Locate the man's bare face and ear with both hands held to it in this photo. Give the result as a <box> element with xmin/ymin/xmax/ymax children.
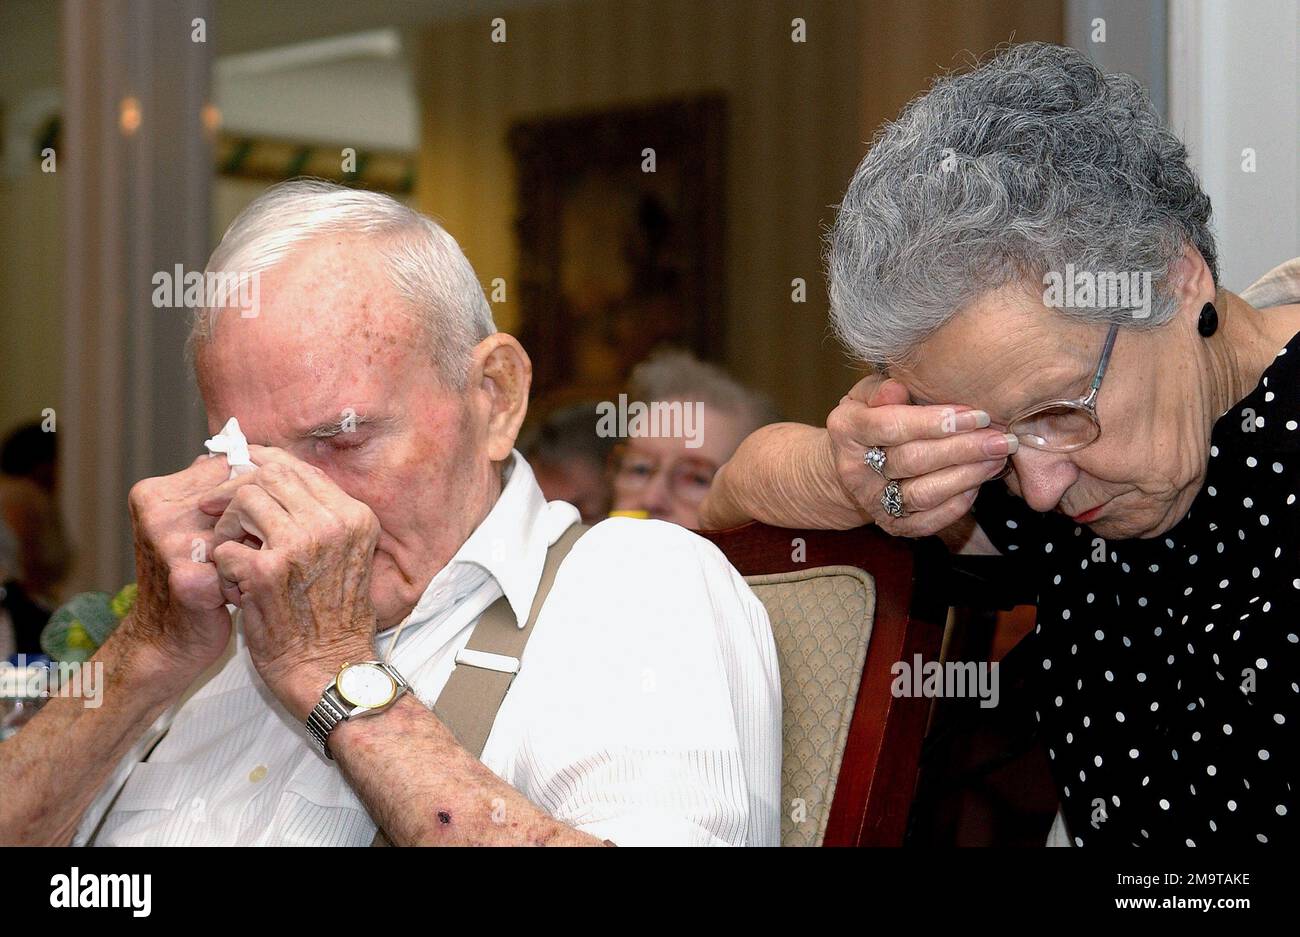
<box><xmin>122</xmin><ymin>237</ymin><xmax>530</xmax><ymax>703</ymax></box>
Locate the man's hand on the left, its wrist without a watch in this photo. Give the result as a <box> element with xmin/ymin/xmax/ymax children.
<box><xmin>122</xmin><ymin>455</ymin><xmax>245</xmax><ymax>691</ymax></box>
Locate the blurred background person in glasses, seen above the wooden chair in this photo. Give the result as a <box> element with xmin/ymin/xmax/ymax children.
<box><xmin>611</xmin><ymin>348</ymin><xmax>780</xmax><ymax>529</ymax></box>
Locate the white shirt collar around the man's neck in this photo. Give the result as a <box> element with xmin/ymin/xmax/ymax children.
<box><xmin>387</xmin><ymin>450</ymin><xmax>579</xmax><ymax>628</ymax></box>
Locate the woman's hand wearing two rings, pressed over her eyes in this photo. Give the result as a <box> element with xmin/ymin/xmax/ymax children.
<box><xmin>826</xmin><ymin>377</ymin><xmax>1019</xmax><ymax>537</ymax></box>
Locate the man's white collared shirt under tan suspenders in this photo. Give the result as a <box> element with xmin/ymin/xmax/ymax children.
<box><xmin>74</xmin><ymin>452</ymin><xmax>781</xmax><ymax>846</ymax></box>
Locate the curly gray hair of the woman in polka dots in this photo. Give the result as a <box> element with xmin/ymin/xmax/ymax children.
<box><xmin>827</xmin><ymin>43</ymin><xmax>1218</xmax><ymax>369</ymax></box>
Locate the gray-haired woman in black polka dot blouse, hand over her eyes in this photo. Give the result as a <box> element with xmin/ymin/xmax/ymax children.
<box><xmin>703</xmin><ymin>44</ymin><xmax>1300</xmax><ymax>846</ymax></box>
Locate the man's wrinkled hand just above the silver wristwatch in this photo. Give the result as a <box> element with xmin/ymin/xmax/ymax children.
<box><xmin>202</xmin><ymin>446</ymin><xmax>380</xmax><ymax>719</ymax></box>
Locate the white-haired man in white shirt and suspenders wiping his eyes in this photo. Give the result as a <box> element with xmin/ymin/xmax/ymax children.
<box><xmin>0</xmin><ymin>182</ymin><xmax>780</xmax><ymax>845</ymax></box>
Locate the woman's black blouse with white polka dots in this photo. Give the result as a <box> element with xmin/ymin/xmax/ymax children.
<box><xmin>975</xmin><ymin>335</ymin><xmax>1300</xmax><ymax>846</ymax></box>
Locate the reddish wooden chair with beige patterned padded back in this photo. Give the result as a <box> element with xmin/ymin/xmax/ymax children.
<box><xmin>699</xmin><ymin>524</ymin><xmax>948</xmax><ymax>846</ymax></box>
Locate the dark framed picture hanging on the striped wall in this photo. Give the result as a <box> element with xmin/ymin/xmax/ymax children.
<box><xmin>510</xmin><ymin>96</ymin><xmax>725</xmax><ymax>403</ymax></box>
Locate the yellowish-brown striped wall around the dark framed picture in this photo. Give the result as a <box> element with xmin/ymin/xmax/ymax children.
<box><xmin>413</xmin><ymin>0</ymin><xmax>1061</xmax><ymax>421</ymax></box>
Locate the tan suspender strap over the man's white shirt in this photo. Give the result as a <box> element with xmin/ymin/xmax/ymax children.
<box><xmin>371</xmin><ymin>524</ymin><xmax>590</xmax><ymax>846</ymax></box>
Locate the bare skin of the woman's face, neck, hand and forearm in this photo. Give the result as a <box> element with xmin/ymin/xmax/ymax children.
<box><xmin>702</xmin><ymin>246</ymin><xmax>1300</xmax><ymax>552</ymax></box>
